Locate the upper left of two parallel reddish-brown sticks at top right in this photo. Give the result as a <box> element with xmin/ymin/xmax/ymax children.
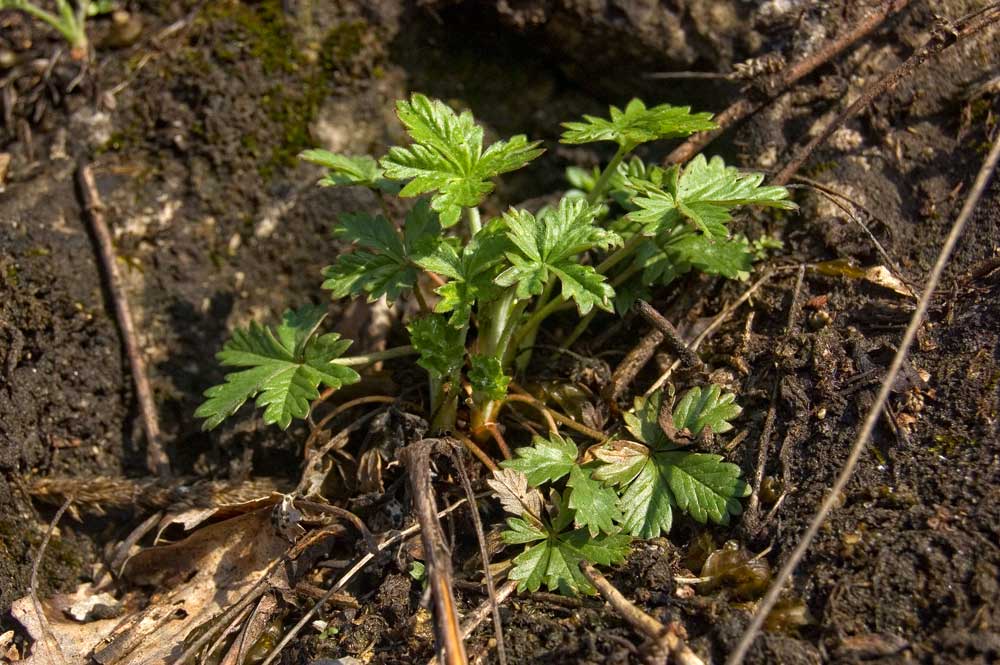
<box><xmin>665</xmin><ymin>0</ymin><xmax>910</xmax><ymax>164</ymax></box>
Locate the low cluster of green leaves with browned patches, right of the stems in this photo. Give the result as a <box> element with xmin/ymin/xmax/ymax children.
<box><xmin>489</xmin><ymin>386</ymin><xmax>750</xmax><ymax>593</ymax></box>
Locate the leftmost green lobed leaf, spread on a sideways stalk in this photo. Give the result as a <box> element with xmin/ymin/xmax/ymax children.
<box><xmin>195</xmin><ymin>306</ymin><xmax>361</xmax><ymax>430</ymax></box>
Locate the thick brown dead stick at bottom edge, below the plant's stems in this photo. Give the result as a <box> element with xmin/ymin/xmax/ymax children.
<box><xmin>402</xmin><ymin>439</ymin><xmax>468</xmax><ymax>665</ymax></box>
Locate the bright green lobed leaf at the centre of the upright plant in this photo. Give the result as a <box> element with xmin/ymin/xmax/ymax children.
<box><xmin>496</xmin><ymin>198</ymin><xmax>621</xmax><ymax>315</ymax></box>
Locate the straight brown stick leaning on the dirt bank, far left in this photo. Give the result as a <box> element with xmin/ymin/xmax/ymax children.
<box><xmin>76</xmin><ymin>164</ymin><xmax>170</xmax><ymax>478</ymax></box>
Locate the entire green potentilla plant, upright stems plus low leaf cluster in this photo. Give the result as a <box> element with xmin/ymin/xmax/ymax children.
<box><xmin>197</xmin><ymin>94</ymin><xmax>795</xmax><ymax>592</ymax></box>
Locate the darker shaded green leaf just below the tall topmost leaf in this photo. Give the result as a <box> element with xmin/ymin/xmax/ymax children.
<box><xmin>323</xmin><ymin>200</ymin><xmax>441</xmax><ymax>302</ymax></box>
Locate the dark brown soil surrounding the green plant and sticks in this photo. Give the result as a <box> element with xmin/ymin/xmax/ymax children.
<box><xmin>0</xmin><ymin>0</ymin><xmax>1000</xmax><ymax>663</ymax></box>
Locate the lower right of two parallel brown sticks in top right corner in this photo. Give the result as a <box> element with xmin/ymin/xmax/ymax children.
<box><xmin>772</xmin><ymin>3</ymin><xmax>1000</xmax><ymax>185</ymax></box>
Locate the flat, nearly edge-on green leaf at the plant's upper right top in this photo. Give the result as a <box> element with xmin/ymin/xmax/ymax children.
<box><xmin>561</xmin><ymin>99</ymin><xmax>716</xmax><ymax>150</ymax></box>
